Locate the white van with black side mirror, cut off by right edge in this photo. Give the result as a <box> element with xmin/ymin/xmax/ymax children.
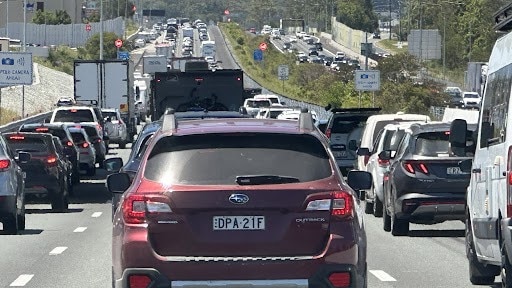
<box><xmin>450</xmin><ymin>9</ymin><xmax>512</xmax><ymax>287</ymax></box>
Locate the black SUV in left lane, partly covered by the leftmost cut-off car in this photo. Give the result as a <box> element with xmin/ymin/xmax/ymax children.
<box><xmin>4</xmin><ymin>132</ymin><xmax>69</xmax><ymax>211</ymax></box>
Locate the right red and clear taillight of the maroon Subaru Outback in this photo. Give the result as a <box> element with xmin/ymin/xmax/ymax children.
<box><xmin>306</xmin><ymin>191</ymin><xmax>354</xmax><ymax>218</ymax></box>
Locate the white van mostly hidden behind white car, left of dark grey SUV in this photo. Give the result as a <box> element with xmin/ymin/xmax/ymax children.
<box><xmin>357</xmin><ymin>112</ymin><xmax>430</xmax><ymax>171</ymax></box>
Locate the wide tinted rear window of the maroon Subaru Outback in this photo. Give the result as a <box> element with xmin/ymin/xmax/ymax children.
<box><xmin>144</xmin><ymin>133</ymin><xmax>332</xmax><ymax>185</ymax></box>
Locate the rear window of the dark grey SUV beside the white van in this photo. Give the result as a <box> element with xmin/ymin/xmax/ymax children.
<box><xmin>414</xmin><ymin>131</ymin><xmax>450</xmax><ymax>157</ymax></box>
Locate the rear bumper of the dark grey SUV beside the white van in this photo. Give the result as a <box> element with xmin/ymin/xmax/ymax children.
<box><xmin>395</xmin><ymin>193</ymin><xmax>466</xmax><ymax>224</ymax></box>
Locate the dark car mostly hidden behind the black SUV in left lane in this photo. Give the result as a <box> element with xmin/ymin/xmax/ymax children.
<box><xmin>18</xmin><ymin>123</ymin><xmax>80</xmax><ymax>184</ymax></box>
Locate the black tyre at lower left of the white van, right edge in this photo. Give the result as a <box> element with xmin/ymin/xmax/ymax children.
<box><xmin>465</xmin><ymin>214</ymin><xmax>499</xmax><ymax>285</ymax></box>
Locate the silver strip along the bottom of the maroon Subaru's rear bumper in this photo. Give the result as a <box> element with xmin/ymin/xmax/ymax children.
<box><xmin>171</xmin><ymin>279</ymin><xmax>309</xmax><ymax>288</ymax></box>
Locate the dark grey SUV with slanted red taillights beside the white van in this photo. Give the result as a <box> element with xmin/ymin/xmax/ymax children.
<box><xmin>379</xmin><ymin>122</ymin><xmax>476</xmax><ymax>236</ymax></box>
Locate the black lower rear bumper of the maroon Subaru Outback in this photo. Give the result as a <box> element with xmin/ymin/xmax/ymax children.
<box><xmin>115</xmin><ymin>265</ymin><xmax>366</xmax><ymax>288</ymax></box>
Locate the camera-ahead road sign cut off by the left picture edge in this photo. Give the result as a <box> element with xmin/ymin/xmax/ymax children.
<box><xmin>0</xmin><ymin>52</ymin><xmax>32</xmax><ymax>86</ymax></box>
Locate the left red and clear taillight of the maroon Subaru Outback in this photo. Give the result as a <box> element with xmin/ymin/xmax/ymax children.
<box><xmin>123</xmin><ymin>195</ymin><xmax>172</xmax><ymax>224</ymax></box>
